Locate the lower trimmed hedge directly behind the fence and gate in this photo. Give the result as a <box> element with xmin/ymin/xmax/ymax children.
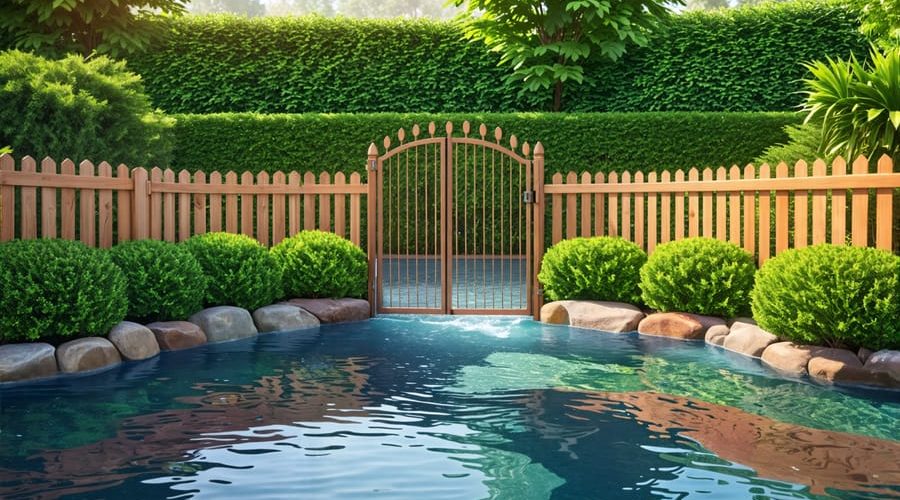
<box><xmin>173</xmin><ymin>113</ymin><xmax>802</xmax><ymax>179</ymax></box>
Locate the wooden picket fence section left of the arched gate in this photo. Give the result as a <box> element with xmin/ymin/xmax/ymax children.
<box><xmin>0</xmin><ymin>154</ymin><xmax>367</xmax><ymax>248</ymax></box>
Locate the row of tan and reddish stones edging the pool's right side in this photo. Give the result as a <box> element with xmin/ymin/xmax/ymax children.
<box><xmin>541</xmin><ymin>300</ymin><xmax>900</xmax><ymax>389</ymax></box>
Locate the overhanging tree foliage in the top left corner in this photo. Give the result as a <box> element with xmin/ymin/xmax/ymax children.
<box><xmin>0</xmin><ymin>0</ymin><xmax>185</xmax><ymax>58</ymax></box>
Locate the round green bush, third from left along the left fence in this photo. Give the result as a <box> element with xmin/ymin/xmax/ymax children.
<box><xmin>182</xmin><ymin>233</ymin><xmax>282</xmax><ymax>310</ymax></box>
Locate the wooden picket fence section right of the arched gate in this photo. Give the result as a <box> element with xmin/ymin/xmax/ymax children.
<box><xmin>544</xmin><ymin>156</ymin><xmax>900</xmax><ymax>264</ymax></box>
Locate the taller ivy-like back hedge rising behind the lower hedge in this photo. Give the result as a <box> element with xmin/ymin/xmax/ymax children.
<box><xmin>128</xmin><ymin>2</ymin><xmax>868</xmax><ymax>113</ymax></box>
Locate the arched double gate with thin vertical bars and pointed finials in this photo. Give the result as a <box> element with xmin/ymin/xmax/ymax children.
<box><xmin>368</xmin><ymin>122</ymin><xmax>544</xmax><ymax>314</ymax></box>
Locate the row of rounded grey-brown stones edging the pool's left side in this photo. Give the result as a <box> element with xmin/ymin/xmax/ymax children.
<box><xmin>0</xmin><ymin>298</ymin><xmax>369</xmax><ymax>385</ymax></box>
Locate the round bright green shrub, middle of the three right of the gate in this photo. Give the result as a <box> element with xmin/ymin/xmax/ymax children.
<box><xmin>641</xmin><ymin>238</ymin><xmax>756</xmax><ymax>317</ymax></box>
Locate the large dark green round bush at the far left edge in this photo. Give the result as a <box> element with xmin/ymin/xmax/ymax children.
<box><xmin>0</xmin><ymin>240</ymin><xmax>128</xmax><ymax>342</ymax></box>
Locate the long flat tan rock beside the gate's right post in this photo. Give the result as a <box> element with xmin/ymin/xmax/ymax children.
<box><xmin>541</xmin><ymin>300</ymin><xmax>644</xmax><ymax>333</ymax></box>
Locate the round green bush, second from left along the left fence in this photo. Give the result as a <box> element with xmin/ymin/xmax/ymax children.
<box><xmin>110</xmin><ymin>240</ymin><xmax>206</xmax><ymax>323</ymax></box>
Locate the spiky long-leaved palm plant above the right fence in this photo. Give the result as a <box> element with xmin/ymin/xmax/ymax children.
<box><xmin>803</xmin><ymin>48</ymin><xmax>900</xmax><ymax>160</ymax></box>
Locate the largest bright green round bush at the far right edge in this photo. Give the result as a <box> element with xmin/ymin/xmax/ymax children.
<box><xmin>751</xmin><ymin>244</ymin><xmax>900</xmax><ymax>349</ymax></box>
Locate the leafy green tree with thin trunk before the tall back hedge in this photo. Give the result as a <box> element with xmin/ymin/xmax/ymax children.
<box><xmin>454</xmin><ymin>0</ymin><xmax>681</xmax><ymax>111</ymax></box>
